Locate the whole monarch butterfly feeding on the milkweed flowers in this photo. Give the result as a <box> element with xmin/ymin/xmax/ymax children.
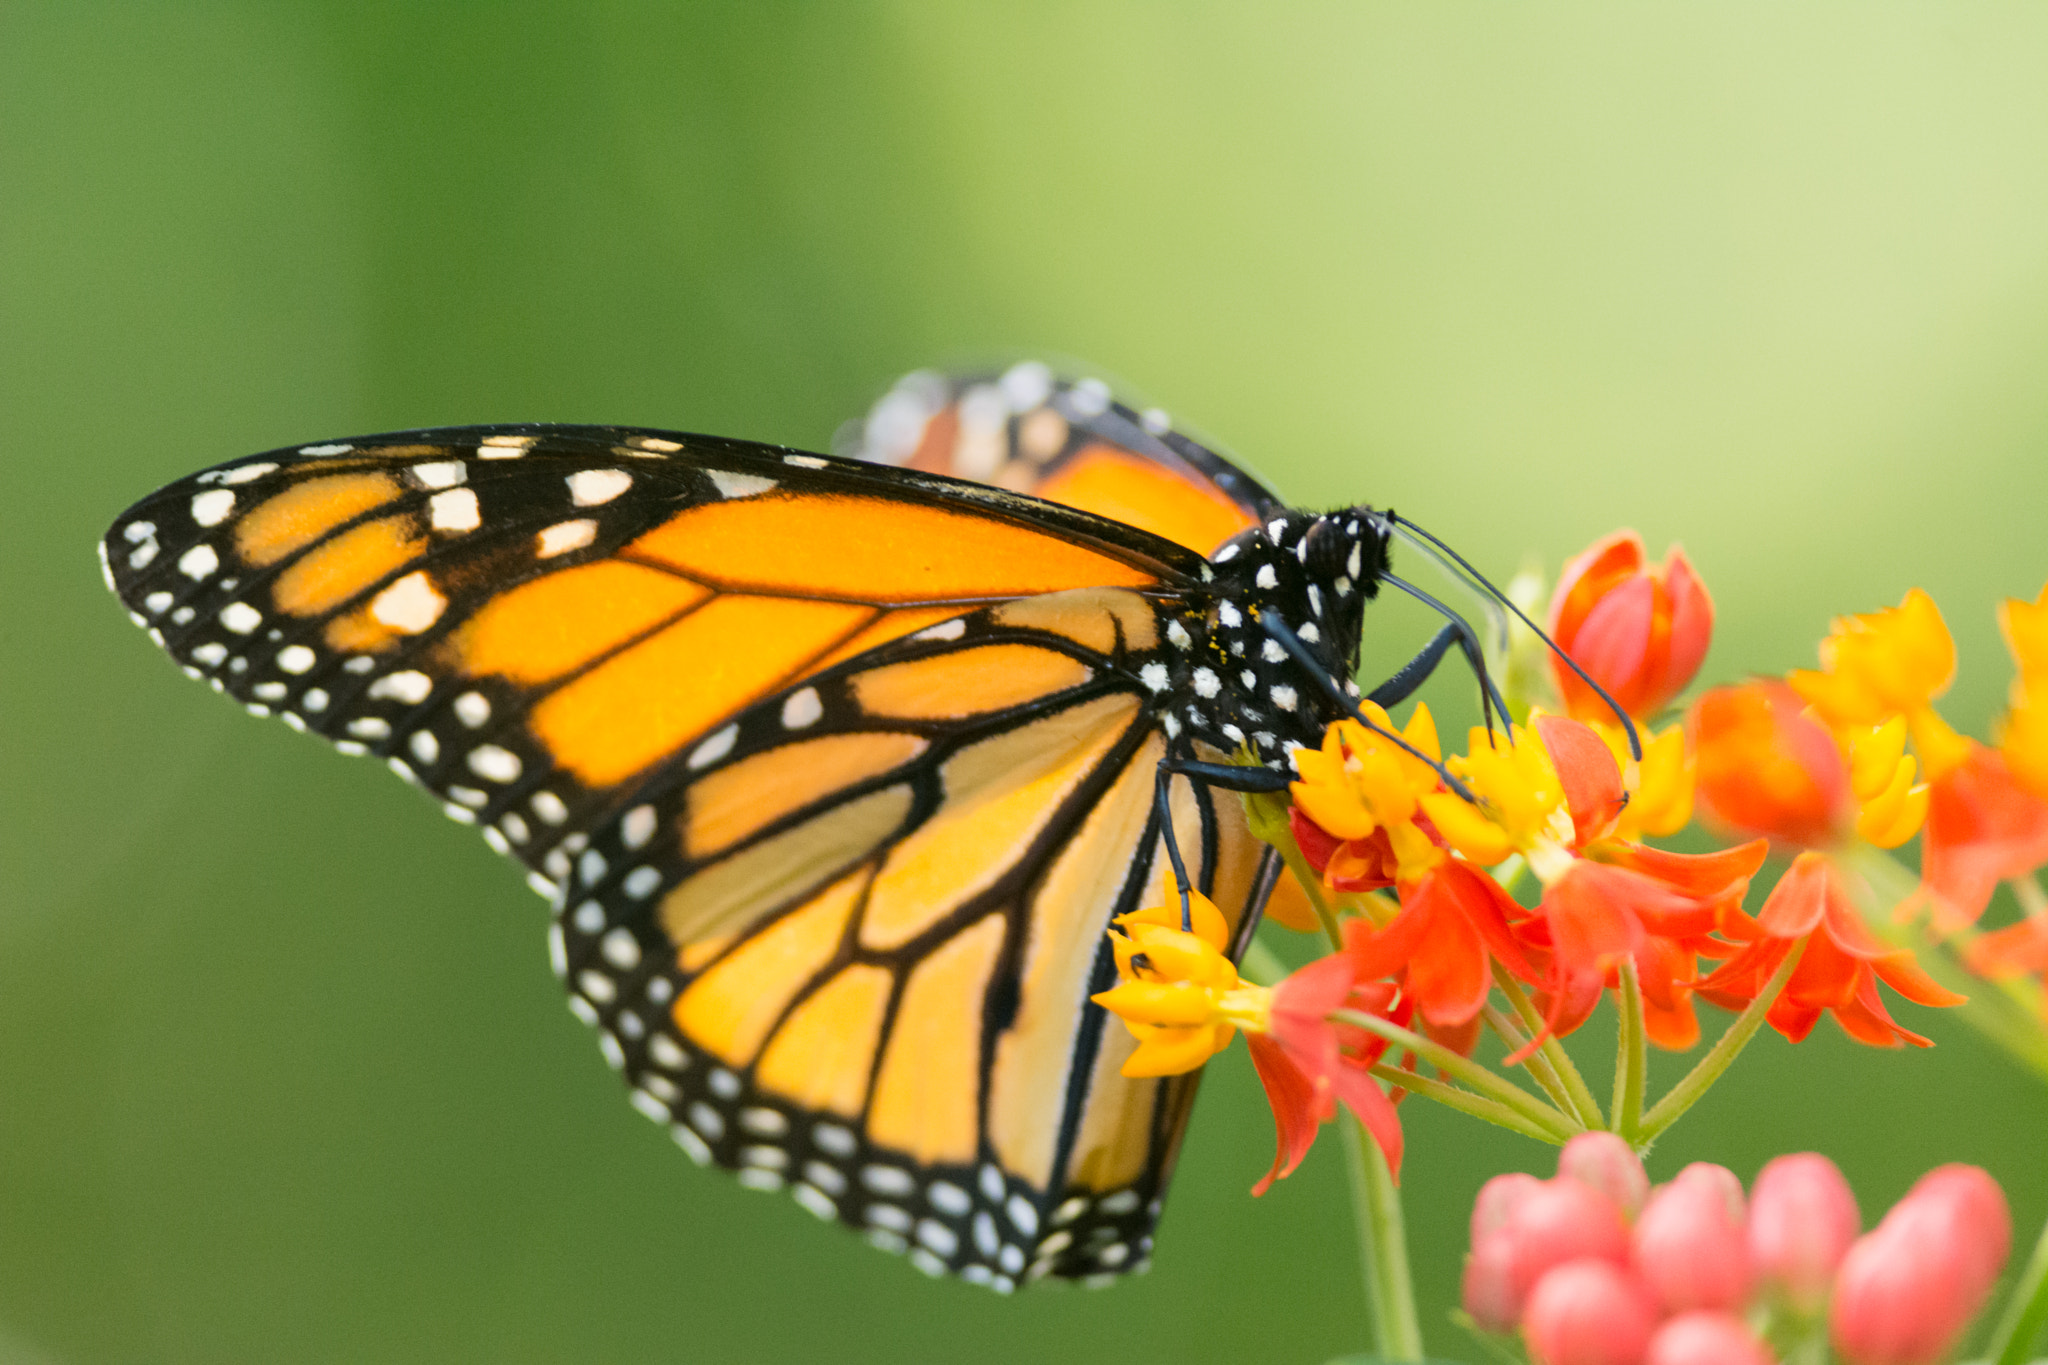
<box><xmin>100</xmin><ymin>364</ymin><xmax>1540</xmax><ymax>1291</ymax></box>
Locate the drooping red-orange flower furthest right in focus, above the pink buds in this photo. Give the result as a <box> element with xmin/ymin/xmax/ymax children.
<box><xmin>1698</xmin><ymin>851</ymin><xmax>1964</xmax><ymax>1048</ymax></box>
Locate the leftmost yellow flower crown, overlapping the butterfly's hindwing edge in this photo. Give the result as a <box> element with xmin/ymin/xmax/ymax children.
<box><xmin>1092</xmin><ymin>884</ymin><xmax>1272</xmax><ymax>1076</ymax></box>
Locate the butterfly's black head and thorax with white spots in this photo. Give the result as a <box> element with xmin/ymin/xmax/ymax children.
<box><xmin>1147</xmin><ymin>508</ymin><xmax>1389</xmax><ymax>765</ymax></box>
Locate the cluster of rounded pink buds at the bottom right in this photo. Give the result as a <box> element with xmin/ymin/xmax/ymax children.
<box><xmin>1464</xmin><ymin>1134</ymin><xmax>2011</xmax><ymax>1365</ymax></box>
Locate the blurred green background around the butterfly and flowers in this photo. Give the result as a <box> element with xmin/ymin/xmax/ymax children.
<box><xmin>0</xmin><ymin>0</ymin><xmax>2048</xmax><ymax>1365</ymax></box>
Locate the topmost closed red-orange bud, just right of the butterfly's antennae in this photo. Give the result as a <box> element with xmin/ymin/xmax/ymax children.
<box><xmin>1550</xmin><ymin>530</ymin><xmax>1714</xmax><ymax>720</ymax></box>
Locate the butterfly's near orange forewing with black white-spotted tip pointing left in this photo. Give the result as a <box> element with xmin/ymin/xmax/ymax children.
<box><xmin>102</xmin><ymin>428</ymin><xmax>1200</xmax><ymax>896</ymax></box>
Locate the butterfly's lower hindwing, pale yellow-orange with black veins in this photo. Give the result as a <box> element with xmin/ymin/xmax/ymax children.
<box><xmin>555</xmin><ymin>589</ymin><xmax>1264</xmax><ymax>1289</ymax></box>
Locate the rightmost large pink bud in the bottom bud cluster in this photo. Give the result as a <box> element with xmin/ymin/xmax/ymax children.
<box><xmin>1829</xmin><ymin>1166</ymin><xmax>2011</xmax><ymax>1365</ymax></box>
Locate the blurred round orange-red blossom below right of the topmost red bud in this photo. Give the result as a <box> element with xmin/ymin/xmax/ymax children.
<box><xmin>1688</xmin><ymin>679</ymin><xmax>1853</xmax><ymax>847</ymax></box>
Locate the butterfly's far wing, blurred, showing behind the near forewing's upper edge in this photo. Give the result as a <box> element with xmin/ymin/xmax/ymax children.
<box><xmin>846</xmin><ymin>360</ymin><xmax>1280</xmax><ymax>555</ymax></box>
